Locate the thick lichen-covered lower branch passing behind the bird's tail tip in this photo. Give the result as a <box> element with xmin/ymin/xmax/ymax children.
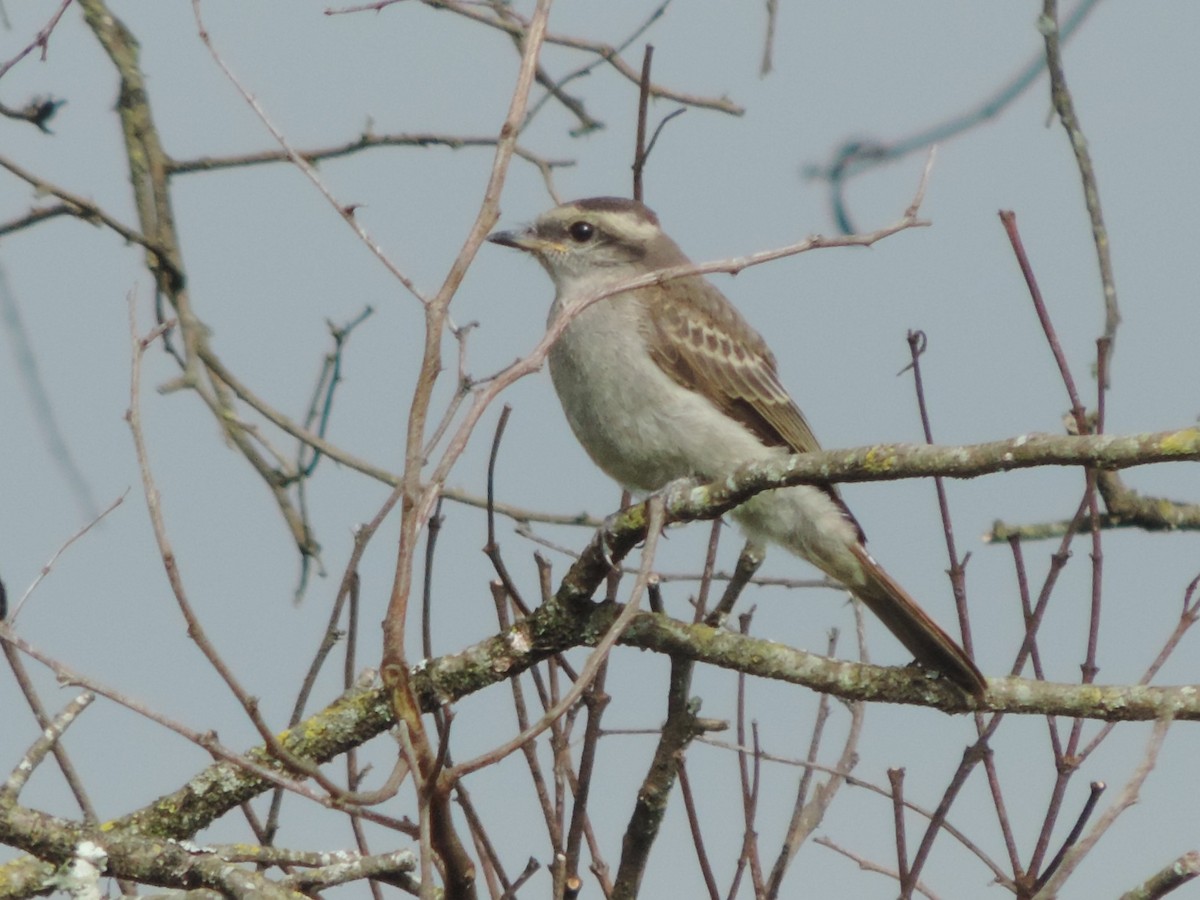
<box><xmin>7</xmin><ymin>585</ymin><xmax>1200</xmax><ymax>887</ymax></box>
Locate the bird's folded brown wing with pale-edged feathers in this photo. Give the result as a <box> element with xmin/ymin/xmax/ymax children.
<box><xmin>642</xmin><ymin>277</ymin><xmax>865</xmax><ymax>540</ymax></box>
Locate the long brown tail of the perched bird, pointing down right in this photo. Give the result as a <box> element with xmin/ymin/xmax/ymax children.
<box><xmin>853</xmin><ymin>544</ymin><xmax>988</xmax><ymax>697</ymax></box>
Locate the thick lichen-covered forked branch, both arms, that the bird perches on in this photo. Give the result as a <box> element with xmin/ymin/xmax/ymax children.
<box><xmin>0</xmin><ymin>428</ymin><xmax>1200</xmax><ymax>880</ymax></box>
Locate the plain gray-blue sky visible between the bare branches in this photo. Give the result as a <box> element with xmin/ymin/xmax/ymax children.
<box><xmin>0</xmin><ymin>0</ymin><xmax>1200</xmax><ymax>898</ymax></box>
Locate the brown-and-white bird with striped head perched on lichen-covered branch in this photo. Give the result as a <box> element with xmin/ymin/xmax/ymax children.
<box><xmin>488</xmin><ymin>197</ymin><xmax>986</xmax><ymax>697</ymax></box>
